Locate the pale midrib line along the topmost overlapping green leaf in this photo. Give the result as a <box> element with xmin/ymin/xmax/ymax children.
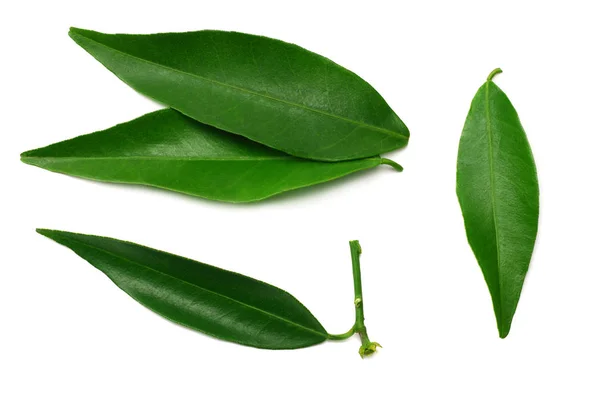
<box><xmin>71</xmin><ymin>31</ymin><xmax>408</xmax><ymax>140</ymax></box>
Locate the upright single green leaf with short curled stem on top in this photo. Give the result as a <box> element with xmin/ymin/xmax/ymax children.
<box><xmin>456</xmin><ymin>69</ymin><xmax>539</xmax><ymax>338</ymax></box>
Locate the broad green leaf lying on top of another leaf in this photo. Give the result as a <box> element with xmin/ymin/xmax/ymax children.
<box><xmin>69</xmin><ymin>28</ymin><xmax>409</xmax><ymax>161</ymax></box>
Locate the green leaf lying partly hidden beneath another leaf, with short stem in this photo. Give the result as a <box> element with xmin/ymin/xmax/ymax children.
<box><xmin>21</xmin><ymin>109</ymin><xmax>402</xmax><ymax>202</ymax></box>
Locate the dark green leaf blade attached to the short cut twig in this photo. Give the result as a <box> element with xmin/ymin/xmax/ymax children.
<box><xmin>37</xmin><ymin>229</ymin><xmax>328</xmax><ymax>349</ymax></box>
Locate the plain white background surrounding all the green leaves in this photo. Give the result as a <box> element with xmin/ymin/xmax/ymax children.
<box><xmin>0</xmin><ymin>0</ymin><xmax>600</xmax><ymax>400</ymax></box>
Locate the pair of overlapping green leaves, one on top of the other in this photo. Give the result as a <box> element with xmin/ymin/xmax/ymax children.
<box><xmin>22</xmin><ymin>28</ymin><xmax>409</xmax><ymax>202</ymax></box>
